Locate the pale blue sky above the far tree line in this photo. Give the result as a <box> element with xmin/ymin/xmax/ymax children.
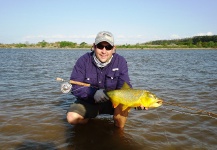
<box><xmin>0</xmin><ymin>0</ymin><xmax>217</xmax><ymax>45</ymax></box>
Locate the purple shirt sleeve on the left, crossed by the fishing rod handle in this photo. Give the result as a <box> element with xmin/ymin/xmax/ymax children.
<box><xmin>70</xmin><ymin>56</ymin><xmax>98</xmax><ymax>103</ymax></box>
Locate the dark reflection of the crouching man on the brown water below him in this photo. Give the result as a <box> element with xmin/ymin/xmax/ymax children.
<box><xmin>66</xmin><ymin>118</ymin><xmax>141</xmax><ymax>150</ymax></box>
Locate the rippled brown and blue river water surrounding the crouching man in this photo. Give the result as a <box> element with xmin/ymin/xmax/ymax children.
<box><xmin>0</xmin><ymin>49</ymin><xmax>217</xmax><ymax>150</ymax></box>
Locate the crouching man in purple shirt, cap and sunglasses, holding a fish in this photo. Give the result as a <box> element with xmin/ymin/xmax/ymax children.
<box><xmin>67</xmin><ymin>31</ymin><xmax>132</xmax><ymax>128</ymax></box>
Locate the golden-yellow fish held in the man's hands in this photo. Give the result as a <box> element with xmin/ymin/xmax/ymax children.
<box><xmin>106</xmin><ymin>83</ymin><xmax>163</xmax><ymax>110</ymax></box>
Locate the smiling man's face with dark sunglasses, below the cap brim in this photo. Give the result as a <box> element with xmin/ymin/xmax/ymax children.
<box><xmin>94</xmin><ymin>42</ymin><xmax>115</xmax><ymax>63</ymax></box>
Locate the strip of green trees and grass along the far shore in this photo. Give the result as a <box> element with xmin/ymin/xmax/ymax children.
<box><xmin>0</xmin><ymin>35</ymin><xmax>217</xmax><ymax>49</ymax></box>
